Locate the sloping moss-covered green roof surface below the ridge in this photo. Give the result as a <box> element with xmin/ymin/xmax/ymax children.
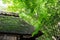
<box><xmin>0</xmin><ymin>15</ymin><xmax>34</xmax><ymax>34</ymax></box>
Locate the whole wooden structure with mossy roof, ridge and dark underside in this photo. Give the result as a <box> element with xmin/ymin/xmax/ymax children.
<box><xmin>0</xmin><ymin>11</ymin><xmax>43</xmax><ymax>40</ymax></box>
